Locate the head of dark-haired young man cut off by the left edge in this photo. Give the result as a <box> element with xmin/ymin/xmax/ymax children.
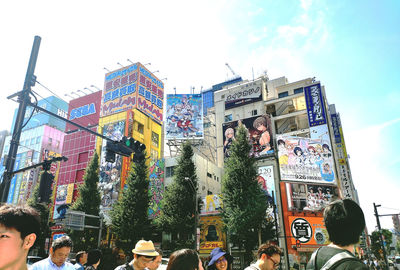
<box><xmin>0</xmin><ymin>204</ymin><xmax>40</xmax><ymax>269</ymax></box>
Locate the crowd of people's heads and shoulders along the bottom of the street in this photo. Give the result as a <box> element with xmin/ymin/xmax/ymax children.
<box><xmin>0</xmin><ymin>199</ymin><xmax>382</xmax><ymax>270</ymax></box>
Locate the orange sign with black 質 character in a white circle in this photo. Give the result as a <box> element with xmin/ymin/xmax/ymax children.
<box><xmin>288</xmin><ymin>216</ymin><xmax>329</xmax><ymax>246</ymax></box>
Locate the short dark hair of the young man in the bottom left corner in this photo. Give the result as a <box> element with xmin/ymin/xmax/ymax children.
<box><xmin>0</xmin><ymin>204</ymin><xmax>40</xmax><ymax>240</ymax></box>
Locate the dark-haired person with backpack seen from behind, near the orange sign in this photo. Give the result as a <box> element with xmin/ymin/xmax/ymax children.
<box><xmin>307</xmin><ymin>199</ymin><xmax>368</xmax><ymax>270</ymax></box>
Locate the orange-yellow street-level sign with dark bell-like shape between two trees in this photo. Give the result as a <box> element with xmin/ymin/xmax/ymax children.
<box><xmin>199</xmin><ymin>216</ymin><xmax>226</xmax><ymax>254</ymax></box>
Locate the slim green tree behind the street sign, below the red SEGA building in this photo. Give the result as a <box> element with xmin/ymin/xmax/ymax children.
<box><xmin>70</xmin><ymin>152</ymin><xmax>101</xmax><ymax>251</ymax></box>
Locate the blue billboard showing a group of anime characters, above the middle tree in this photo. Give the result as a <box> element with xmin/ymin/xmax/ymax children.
<box><xmin>165</xmin><ymin>94</ymin><xmax>204</xmax><ymax>140</ymax></box>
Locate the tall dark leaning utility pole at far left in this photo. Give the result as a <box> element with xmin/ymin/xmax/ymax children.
<box><xmin>0</xmin><ymin>36</ymin><xmax>41</xmax><ymax>202</ymax></box>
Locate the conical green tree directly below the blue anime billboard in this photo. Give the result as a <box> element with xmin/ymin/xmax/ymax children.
<box><xmin>155</xmin><ymin>142</ymin><xmax>200</xmax><ymax>250</ymax></box>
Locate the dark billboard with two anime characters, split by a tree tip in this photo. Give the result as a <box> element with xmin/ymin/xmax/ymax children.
<box><xmin>222</xmin><ymin>114</ymin><xmax>274</xmax><ymax>158</ymax></box>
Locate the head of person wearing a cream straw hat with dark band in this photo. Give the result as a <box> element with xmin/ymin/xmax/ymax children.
<box><xmin>132</xmin><ymin>240</ymin><xmax>159</xmax><ymax>270</ymax></box>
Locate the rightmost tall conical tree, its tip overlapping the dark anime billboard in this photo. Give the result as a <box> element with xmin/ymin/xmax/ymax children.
<box><xmin>222</xmin><ymin>125</ymin><xmax>268</xmax><ymax>264</ymax></box>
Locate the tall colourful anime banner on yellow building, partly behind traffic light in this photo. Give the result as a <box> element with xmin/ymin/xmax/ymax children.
<box><xmin>99</xmin><ymin>121</ymin><xmax>125</xmax><ymax>225</ymax></box>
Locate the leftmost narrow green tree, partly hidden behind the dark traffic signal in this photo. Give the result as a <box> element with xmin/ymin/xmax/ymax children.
<box><xmin>28</xmin><ymin>180</ymin><xmax>50</xmax><ymax>256</ymax></box>
